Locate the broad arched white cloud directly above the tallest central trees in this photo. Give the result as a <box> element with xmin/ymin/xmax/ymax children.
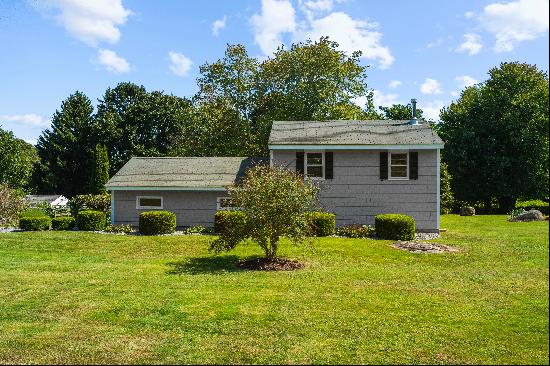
<box><xmin>295</xmin><ymin>12</ymin><xmax>394</xmax><ymax>69</ymax></box>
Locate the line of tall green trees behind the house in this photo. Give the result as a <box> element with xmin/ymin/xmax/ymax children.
<box><xmin>0</xmin><ymin>38</ymin><xmax>548</xmax><ymax>212</ymax></box>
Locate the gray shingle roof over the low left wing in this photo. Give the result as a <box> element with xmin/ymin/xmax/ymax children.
<box><xmin>106</xmin><ymin>157</ymin><xmax>262</xmax><ymax>189</ymax></box>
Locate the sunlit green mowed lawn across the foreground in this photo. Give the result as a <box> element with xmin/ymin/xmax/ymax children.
<box><xmin>0</xmin><ymin>215</ymin><xmax>549</xmax><ymax>364</ymax></box>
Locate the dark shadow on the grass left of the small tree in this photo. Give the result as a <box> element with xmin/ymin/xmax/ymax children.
<box><xmin>166</xmin><ymin>255</ymin><xmax>242</xmax><ymax>275</ymax></box>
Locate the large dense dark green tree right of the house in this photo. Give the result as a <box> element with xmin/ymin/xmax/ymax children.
<box><xmin>437</xmin><ymin>62</ymin><xmax>549</xmax><ymax>212</ymax></box>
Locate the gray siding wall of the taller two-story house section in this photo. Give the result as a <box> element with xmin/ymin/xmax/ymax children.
<box><xmin>272</xmin><ymin>149</ymin><xmax>438</xmax><ymax>231</ymax></box>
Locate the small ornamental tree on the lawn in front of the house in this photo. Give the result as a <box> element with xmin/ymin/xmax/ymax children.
<box><xmin>210</xmin><ymin>165</ymin><xmax>319</xmax><ymax>259</ymax></box>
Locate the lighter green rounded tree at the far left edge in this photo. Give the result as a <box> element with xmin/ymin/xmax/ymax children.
<box><xmin>0</xmin><ymin>128</ymin><xmax>38</xmax><ymax>188</ymax></box>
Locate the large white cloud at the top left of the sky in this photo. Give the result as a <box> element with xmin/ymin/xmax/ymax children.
<box><xmin>42</xmin><ymin>0</ymin><xmax>132</xmax><ymax>47</ymax></box>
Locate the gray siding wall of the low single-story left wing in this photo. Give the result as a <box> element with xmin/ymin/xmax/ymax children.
<box><xmin>111</xmin><ymin>191</ymin><xmax>227</xmax><ymax>227</ymax></box>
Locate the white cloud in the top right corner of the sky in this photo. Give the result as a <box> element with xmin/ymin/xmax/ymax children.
<box><xmin>480</xmin><ymin>0</ymin><xmax>549</xmax><ymax>52</ymax></box>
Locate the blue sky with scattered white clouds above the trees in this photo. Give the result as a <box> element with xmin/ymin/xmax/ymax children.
<box><xmin>0</xmin><ymin>0</ymin><xmax>549</xmax><ymax>143</ymax></box>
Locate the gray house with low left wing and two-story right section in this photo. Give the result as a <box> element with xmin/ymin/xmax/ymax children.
<box><xmin>106</xmin><ymin>119</ymin><xmax>443</xmax><ymax>232</ymax></box>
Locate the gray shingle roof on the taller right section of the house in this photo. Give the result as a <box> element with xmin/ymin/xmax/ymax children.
<box><xmin>269</xmin><ymin>120</ymin><xmax>443</xmax><ymax>145</ymax></box>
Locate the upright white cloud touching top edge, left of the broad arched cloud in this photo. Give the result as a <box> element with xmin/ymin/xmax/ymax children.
<box><xmin>251</xmin><ymin>0</ymin><xmax>296</xmax><ymax>55</ymax></box>
